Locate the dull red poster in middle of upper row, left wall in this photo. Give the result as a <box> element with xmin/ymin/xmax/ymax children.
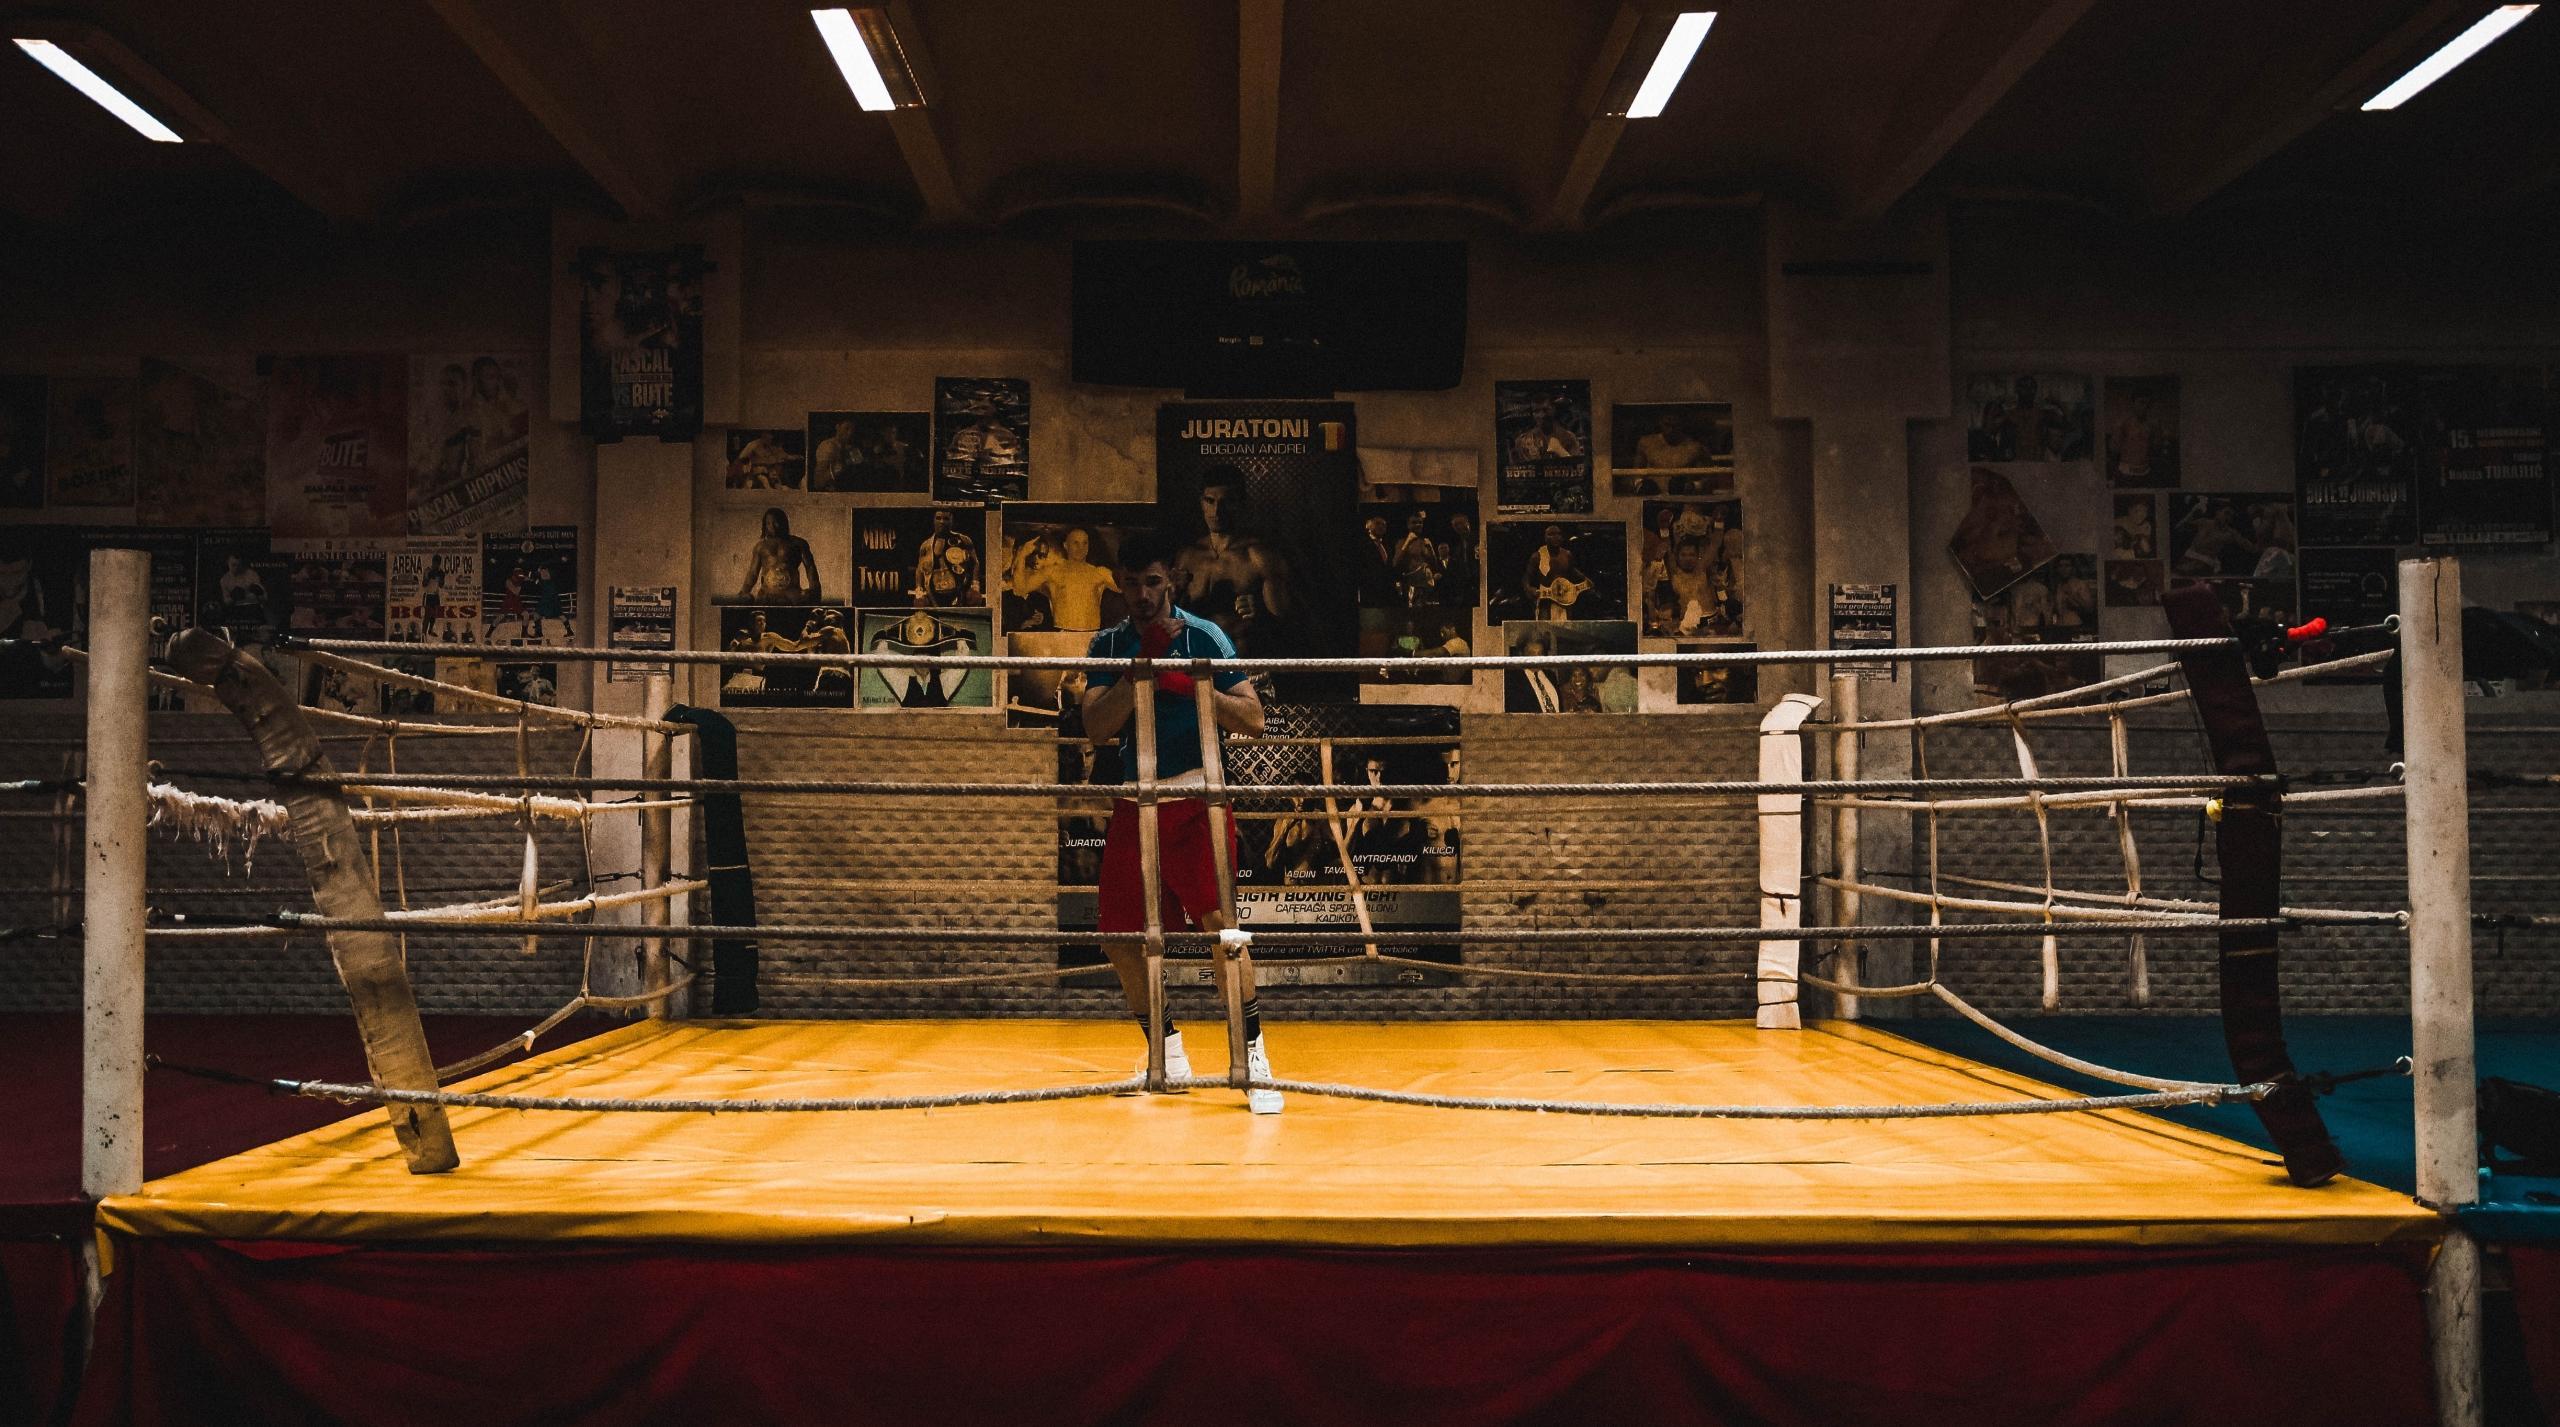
<box><xmin>259</xmin><ymin>354</ymin><xmax>410</xmax><ymax>551</ymax></box>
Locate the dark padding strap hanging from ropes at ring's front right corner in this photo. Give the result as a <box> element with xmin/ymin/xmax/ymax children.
<box><xmin>2160</xmin><ymin>584</ymin><xmax>2345</xmax><ymax>1186</ymax></box>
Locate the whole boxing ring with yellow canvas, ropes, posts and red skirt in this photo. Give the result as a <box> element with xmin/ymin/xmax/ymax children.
<box><xmin>20</xmin><ymin>551</ymin><xmax>2539</xmax><ymax>1422</ymax></box>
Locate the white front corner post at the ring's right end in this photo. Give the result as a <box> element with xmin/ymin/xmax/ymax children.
<box><xmin>2399</xmin><ymin>556</ymin><xmax>2483</xmax><ymax>1427</ymax></box>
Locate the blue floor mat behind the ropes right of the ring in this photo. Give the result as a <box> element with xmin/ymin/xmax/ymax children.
<box><xmin>1871</xmin><ymin>1015</ymin><xmax>2560</xmax><ymax>1243</ymax></box>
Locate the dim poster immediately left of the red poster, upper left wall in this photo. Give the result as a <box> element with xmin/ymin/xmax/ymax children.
<box><xmin>133</xmin><ymin>356</ymin><xmax>266</xmax><ymax>525</ymax></box>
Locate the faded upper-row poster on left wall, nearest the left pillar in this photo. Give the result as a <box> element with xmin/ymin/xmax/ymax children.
<box><xmin>410</xmin><ymin>351</ymin><xmax>543</xmax><ymax>535</ymax></box>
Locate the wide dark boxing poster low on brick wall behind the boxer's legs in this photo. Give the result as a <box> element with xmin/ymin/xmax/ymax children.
<box><xmin>1057</xmin><ymin>696</ymin><xmax>1464</xmax><ymax>986</ymax></box>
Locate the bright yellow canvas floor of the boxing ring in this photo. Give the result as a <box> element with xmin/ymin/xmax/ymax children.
<box><xmin>100</xmin><ymin>1020</ymin><xmax>2437</xmax><ymax>1248</ymax></box>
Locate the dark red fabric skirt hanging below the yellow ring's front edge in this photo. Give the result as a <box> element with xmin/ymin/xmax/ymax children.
<box><xmin>82</xmin><ymin>1240</ymin><xmax>2432</xmax><ymax>1427</ymax></box>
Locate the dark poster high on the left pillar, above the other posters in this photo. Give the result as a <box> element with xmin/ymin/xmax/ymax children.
<box><xmin>579</xmin><ymin>243</ymin><xmax>709</xmax><ymax>441</ymax></box>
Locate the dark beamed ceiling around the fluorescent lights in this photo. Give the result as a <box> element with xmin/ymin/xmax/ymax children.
<box><xmin>0</xmin><ymin>0</ymin><xmax>2560</xmax><ymax>233</ymax></box>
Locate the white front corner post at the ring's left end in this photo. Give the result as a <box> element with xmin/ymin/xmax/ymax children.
<box><xmin>79</xmin><ymin>551</ymin><xmax>151</xmax><ymax>1199</ymax></box>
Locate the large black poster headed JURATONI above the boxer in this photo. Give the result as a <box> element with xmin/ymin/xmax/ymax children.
<box><xmin>1155</xmin><ymin>402</ymin><xmax>1359</xmax><ymax>702</ymax></box>
